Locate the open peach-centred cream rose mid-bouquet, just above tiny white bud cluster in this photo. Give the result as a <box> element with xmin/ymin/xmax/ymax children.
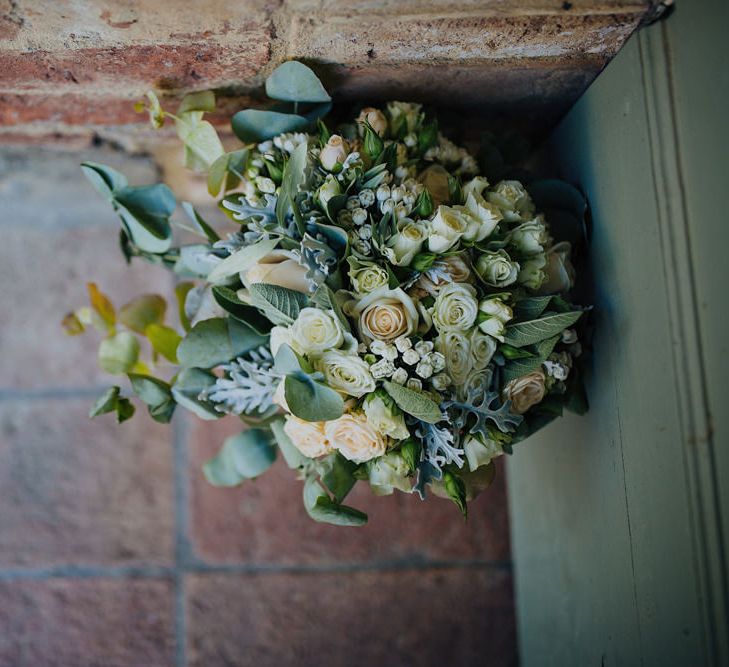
<box><xmin>345</xmin><ymin>287</ymin><xmax>418</xmax><ymax>342</ymax></box>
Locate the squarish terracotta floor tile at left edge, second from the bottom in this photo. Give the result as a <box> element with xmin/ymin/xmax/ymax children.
<box><xmin>0</xmin><ymin>398</ymin><xmax>174</xmax><ymax>568</ymax></box>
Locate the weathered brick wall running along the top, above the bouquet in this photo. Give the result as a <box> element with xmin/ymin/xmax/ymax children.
<box><xmin>0</xmin><ymin>0</ymin><xmax>650</xmax><ymax>141</ymax></box>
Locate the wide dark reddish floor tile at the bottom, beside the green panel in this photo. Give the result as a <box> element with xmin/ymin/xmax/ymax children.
<box><xmin>187</xmin><ymin>570</ymin><xmax>517</xmax><ymax>667</ymax></box>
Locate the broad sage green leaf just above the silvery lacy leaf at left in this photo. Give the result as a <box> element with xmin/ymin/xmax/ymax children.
<box><xmin>177</xmin><ymin>317</ymin><xmax>267</xmax><ymax>368</ymax></box>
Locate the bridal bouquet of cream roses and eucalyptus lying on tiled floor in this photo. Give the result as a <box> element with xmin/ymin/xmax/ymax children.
<box><xmin>64</xmin><ymin>62</ymin><xmax>585</xmax><ymax>525</ymax></box>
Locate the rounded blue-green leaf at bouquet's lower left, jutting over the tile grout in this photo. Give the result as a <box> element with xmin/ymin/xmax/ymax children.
<box><xmin>203</xmin><ymin>428</ymin><xmax>276</xmax><ymax>486</ymax></box>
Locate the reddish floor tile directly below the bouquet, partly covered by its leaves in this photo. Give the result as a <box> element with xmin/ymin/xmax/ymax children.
<box><xmin>185</xmin><ymin>418</ymin><xmax>509</xmax><ymax>564</ymax></box>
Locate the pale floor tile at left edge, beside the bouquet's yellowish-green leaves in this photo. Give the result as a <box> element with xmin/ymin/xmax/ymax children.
<box><xmin>0</xmin><ymin>150</ymin><xmax>174</xmax><ymax>389</ymax></box>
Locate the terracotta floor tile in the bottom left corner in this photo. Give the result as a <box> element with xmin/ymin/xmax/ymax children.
<box><xmin>0</xmin><ymin>579</ymin><xmax>174</xmax><ymax>667</ymax></box>
